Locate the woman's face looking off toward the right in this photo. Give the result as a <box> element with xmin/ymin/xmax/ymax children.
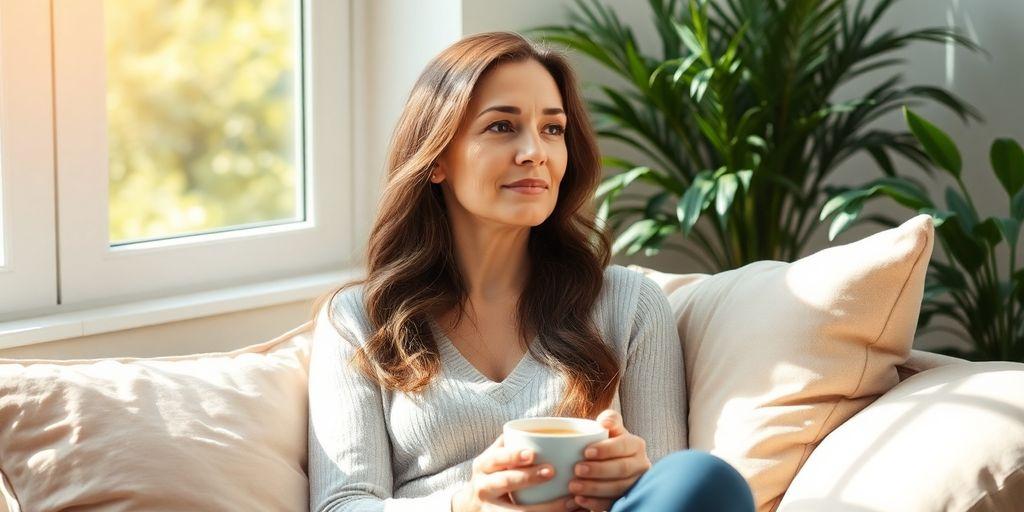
<box><xmin>431</xmin><ymin>59</ymin><xmax>567</xmax><ymax>226</ymax></box>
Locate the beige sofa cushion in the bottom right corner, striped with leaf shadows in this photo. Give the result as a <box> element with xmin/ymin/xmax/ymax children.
<box><xmin>779</xmin><ymin>362</ymin><xmax>1024</xmax><ymax>512</ymax></box>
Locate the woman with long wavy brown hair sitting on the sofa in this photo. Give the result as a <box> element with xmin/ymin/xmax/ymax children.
<box><xmin>308</xmin><ymin>33</ymin><xmax>753</xmax><ymax>512</ymax></box>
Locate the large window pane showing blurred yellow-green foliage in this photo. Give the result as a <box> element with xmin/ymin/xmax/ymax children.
<box><xmin>103</xmin><ymin>0</ymin><xmax>305</xmax><ymax>245</ymax></box>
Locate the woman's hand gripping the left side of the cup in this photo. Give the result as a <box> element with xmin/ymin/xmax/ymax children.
<box><xmin>452</xmin><ymin>434</ymin><xmax>583</xmax><ymax>512</ymax></box>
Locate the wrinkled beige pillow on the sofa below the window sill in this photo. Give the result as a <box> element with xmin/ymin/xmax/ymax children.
<box><xmin>0</xmin><ymin>323</ymin><xmax>310</xmax><ymax>512</ymax></box>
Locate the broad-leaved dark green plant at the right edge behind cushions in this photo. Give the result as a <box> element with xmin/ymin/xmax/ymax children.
<box><xmin>820</xmin><ymin>110</ymin><xmax>1024</xmax><ymax>361</ymax></box>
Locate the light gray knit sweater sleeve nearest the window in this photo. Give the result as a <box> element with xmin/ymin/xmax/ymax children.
<box><xmin>308</xmin><ymin>300</ymin><xmax>454</xmax><ymax>512</ymax></box>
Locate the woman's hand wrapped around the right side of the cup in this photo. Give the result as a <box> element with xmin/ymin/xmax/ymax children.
<box><xmin>569</xmin><ymin>409</ymin><xmax>650</xmax><ymax>511</ymax></box>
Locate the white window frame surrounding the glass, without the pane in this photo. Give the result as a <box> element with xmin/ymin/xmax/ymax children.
<box><xmin>0</xmin><ymin>0</ymin><xmax>356</xmax><ymax>321</ymax></box>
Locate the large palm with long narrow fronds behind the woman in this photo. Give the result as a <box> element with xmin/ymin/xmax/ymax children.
<box><xmin>526</xmin><ymin>0</ymin><xmax>977</xmax><ymax>271</ymax></box>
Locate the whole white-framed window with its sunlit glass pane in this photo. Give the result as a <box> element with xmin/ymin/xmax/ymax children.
<box><xmin>0</xmin><ymin>0</ymin><xmax>354</xmax><ymax>321</ymax></box>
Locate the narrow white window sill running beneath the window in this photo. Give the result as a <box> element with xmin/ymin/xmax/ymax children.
<box><xmin>0</xmin><ymin>268</ymin><xmax>361</xmax><ymax>350</ymax></box>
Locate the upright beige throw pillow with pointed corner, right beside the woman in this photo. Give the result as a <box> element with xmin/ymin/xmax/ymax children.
<box><xmin>641</xmin><ymin>215</ymin><xmax>934</xmax><ymax>512</ymax></box>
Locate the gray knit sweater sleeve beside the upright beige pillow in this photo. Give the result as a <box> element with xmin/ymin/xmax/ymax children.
<box><xmin>618</xmin><ymin>276</ymin><xmax>688</xmax><ymax>463</ymax></box>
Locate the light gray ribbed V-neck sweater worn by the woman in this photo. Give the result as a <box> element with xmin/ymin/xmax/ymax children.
<box><xmin>309</xmin><ymin>265</ymin><xmax>687</xmax><ymax>512</ymax></box>
